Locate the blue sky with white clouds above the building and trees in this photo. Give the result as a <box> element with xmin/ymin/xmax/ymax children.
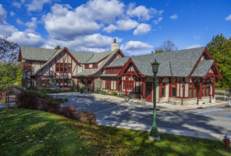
<box><xmin>0</xmin><ymin>0</ymin><xmax>231</xmax><ymax>56</ymax></box>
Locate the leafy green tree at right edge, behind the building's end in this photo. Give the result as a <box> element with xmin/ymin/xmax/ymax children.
<box><xmin>207</xmin><ymin>33</ymin><xmax>231</xmax><ymax>88</ymax></box>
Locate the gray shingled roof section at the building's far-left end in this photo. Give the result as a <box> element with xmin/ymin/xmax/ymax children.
<box><xmin>20</xmin><ymin>46</ymin><xmax>56</xmax><ymax>61</ymax></box>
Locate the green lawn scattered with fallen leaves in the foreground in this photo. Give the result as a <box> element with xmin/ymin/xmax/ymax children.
<box><xmin>0</xmin><ymin>109</ymin><xmax>231</xmax><ymax>156</ymax></box>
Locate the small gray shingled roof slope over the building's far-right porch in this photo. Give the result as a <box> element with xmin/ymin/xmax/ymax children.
<box><xmin>192</xmin><ymin>60</ymin><xmax>214</xmax><ymax>77</ymax></box>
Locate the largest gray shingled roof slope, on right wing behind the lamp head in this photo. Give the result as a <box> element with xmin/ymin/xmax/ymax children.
<box><xmin>131</xmin><ymin>47</ymin><xmax>205</xmax><ymax>77</ymax></box>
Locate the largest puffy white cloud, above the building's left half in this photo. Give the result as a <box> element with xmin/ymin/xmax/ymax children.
<box><xmin>43</xmin><ymin>4</ymin><xmax>100</xmax><ymax>40</ymax></box>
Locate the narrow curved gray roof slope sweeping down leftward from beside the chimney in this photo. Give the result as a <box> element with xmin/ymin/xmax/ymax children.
<box><xmin>72</xmin><ymin>49</ymin><xmax>118</xmax><ymax>77</ymax></box>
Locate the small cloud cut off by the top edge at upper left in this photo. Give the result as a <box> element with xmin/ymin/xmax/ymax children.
<box><xmin>26</xmin><ymin>0</ymin><xmax>52</xmax><ymax>11</ymax></box>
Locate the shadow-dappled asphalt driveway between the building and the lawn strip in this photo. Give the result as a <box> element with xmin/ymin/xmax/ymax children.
<box><xmin>0</xmin><ymin>95</ymin><xmax>231</xmax><ymax>134</ymax></box>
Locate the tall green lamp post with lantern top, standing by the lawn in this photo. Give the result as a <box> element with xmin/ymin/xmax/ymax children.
<box><xmin>148</xmin><ymin>59</ymin><xmax>160</xmax><ymax>141</ymax></box>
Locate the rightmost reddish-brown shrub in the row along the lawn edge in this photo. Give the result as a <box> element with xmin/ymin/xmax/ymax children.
<box><xmin>78</xmin><ymin>111</ymin><xmax>97</xmax><ymax>125</ymax></box>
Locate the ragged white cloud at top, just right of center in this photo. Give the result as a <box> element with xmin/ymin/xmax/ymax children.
<box><xmin>127</xmin><ymin>3</ymin><xmax>163</xmax><ymax>20</ymax></box>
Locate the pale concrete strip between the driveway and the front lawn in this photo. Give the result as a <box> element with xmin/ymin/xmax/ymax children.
<box><xmin>97</xmin><ymin>119</ymin><xmax>225</xmax><ymax>141</ymax></box>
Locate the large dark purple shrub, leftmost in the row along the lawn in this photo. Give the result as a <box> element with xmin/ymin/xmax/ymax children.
<box><xmin>16</xmin><ymin>90</ymin><xmax>38</xmax><ymax>110</ymax></box>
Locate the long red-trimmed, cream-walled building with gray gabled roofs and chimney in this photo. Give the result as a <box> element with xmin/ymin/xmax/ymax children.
<box><xmin>19</xmin><ymin>39</ymin><xmax>222</xmax><ymax>105</ymax></box>
